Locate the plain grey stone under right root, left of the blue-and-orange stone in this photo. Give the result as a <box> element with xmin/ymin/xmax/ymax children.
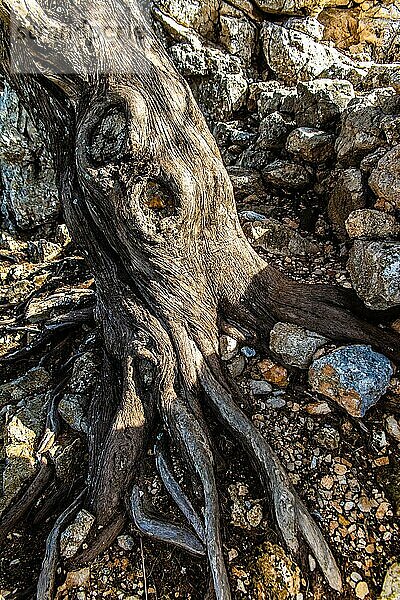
<box><xmin>270</xmin><ymin>323</ymin><xmax>328</xmax><ymax>369</ymax></box>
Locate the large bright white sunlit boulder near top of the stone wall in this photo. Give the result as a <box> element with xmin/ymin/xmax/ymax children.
<box><xmin>262</xmin><ymin>21</ymin><xmax>367</xmax><ymax>85</ymax></box>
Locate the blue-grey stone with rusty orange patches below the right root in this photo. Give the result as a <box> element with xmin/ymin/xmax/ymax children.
<box><xmin>309</xmin><ymin>345</ymin><xmax>393</xmax><ymax>417</ymax></box>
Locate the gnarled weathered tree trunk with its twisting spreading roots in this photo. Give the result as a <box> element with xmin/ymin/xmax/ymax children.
<box><xmin>0</xmin><ymin>0</ymin><xmax>399</xmax><ymax>600</ymax></box>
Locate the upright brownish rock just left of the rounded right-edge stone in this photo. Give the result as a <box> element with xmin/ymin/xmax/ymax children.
<box><xmin>328</xmin><ymin>168</ymin><xmax>366</xmax><ymax>237</ymax></box>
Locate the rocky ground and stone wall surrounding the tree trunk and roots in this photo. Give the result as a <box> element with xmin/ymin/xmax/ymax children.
<box><xmin>0</xmin><ymin>0</ymin><xmax>400</xmax><ymax>600</ymax></box>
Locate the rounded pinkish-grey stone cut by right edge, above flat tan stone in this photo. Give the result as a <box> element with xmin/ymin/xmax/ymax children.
<box><xmin>368</xmin><ymin>144</ymin><xmax>400</xmax><ymax>208</ymax></box>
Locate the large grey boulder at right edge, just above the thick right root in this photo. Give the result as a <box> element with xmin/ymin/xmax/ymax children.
<box><xmin>347</xmin><ymin>240</ymin><xmax>400</xmax><ymax>310</ymax></box>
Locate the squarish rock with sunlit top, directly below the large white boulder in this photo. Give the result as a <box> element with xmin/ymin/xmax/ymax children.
<box><xmin>295</xmin><ymin>79</ymin><xmax>355</xmax><ymax>127</ymax></box>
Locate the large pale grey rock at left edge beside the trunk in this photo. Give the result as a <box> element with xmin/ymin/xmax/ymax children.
<box><xmin>0</xmin><ymin>84</ymin><xmax>60</xmax><ymax>229</ymax></box>
